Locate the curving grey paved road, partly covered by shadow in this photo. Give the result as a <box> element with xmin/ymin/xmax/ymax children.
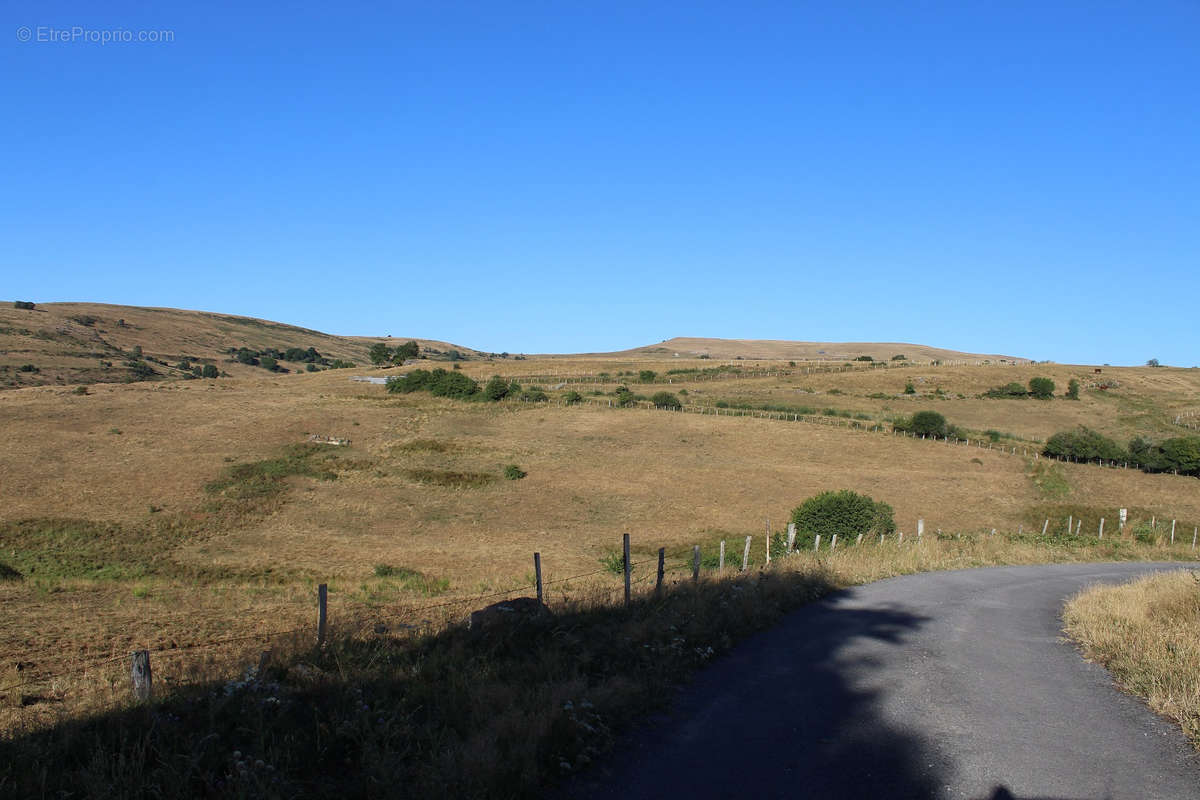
<box><xmin>565</xmin><ymin>564</ymin><xmax>1200</xmax><ymax>800</ymax></box>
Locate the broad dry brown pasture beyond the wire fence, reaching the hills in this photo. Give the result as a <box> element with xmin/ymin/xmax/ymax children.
<box><xmin>0</xmin><ymin>306</ymin><xmax>1200</xmax><ymax>748</ymax></box>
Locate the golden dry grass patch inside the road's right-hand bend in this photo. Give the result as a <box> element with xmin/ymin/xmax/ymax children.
<box><xmin>1063</xmin><ymin>570</ymin><xmax>1200</xmax><ymax>750</ymax></box>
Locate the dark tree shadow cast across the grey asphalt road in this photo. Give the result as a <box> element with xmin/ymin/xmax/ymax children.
<box><xmin>560</xmin><ymin>590</ymin><xmax>950</xmax><ymax>800</ymax></box>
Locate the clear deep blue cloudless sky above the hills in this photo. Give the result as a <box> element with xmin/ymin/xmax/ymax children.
<box><xmin>0</xmin><ymin>0</ymin><xmax>1200</xmax><ymax>366</ymax></box>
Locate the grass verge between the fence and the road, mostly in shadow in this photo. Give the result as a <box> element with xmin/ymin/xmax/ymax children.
<box><xmin>7</xmin><ymin>534</ymin><xmax>1190</xmax><ymax>798</ymax></box>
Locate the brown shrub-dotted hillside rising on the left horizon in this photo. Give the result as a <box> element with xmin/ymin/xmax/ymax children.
<box><xmin>0</xmin><ymin>301</ymin><xmax>480</xmax><ymax>389</ymax></box>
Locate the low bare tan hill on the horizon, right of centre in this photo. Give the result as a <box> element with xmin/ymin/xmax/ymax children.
<box><xmin>556</xmin><ymin>337</ymin><xmax>1030</xmax><ymax>363</ymax></box>
